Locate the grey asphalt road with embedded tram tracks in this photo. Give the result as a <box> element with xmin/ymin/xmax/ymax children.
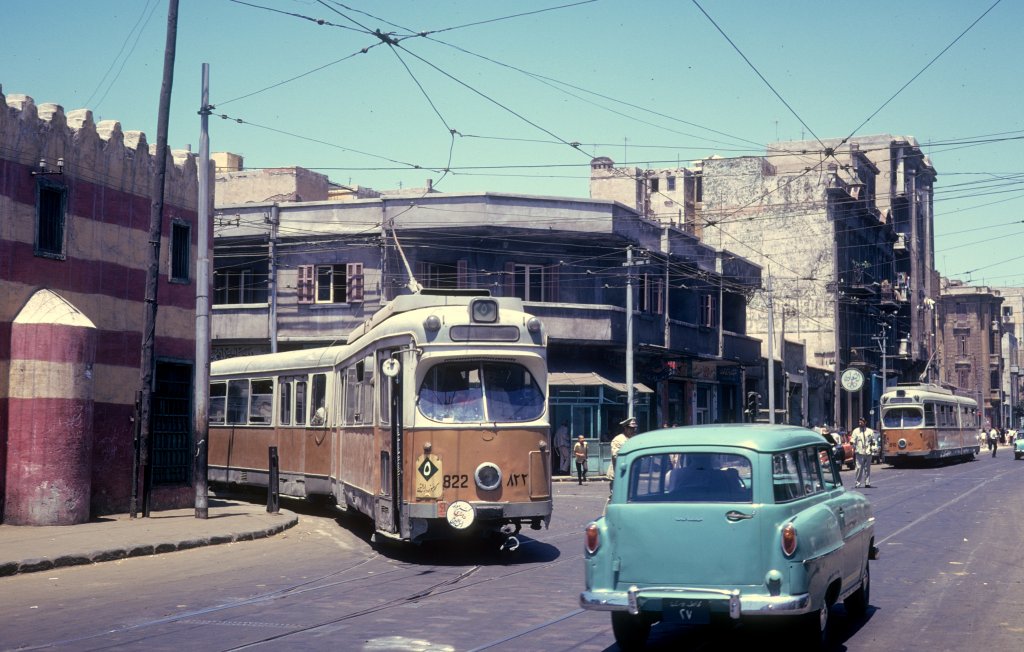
<box><xmin>0</xmin><ymin>448</ymin><xmax>1024</xmax><ymax>652</ymax></box>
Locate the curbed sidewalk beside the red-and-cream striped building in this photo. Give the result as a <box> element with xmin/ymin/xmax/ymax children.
<box><xmin>0</xmin><ymin>497</ymin><xmax>299</xmax><ymax>577</ymax></box>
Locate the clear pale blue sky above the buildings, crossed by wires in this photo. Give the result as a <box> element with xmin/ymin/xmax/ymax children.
<box><xmin>0</xmin><ymin>0</ymin><xmax>1024</xmax><ymax>286</ymax></box>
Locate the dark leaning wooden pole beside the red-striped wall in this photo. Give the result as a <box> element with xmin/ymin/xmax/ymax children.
<box><xmin>130</xmin><ymin>0</ymin><xmax>178</xmax><ymax>518</ymax></box>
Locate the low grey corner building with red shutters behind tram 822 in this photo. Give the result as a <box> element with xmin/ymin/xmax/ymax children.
<box><xmin>212</xmin><ymin>188</ymin><xmax>761</xmax><ymax>438</ymax></box>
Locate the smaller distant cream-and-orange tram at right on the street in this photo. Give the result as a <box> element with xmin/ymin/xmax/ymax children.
<box><xmin>880</xmin><ymin>384</ymin><xmax>981</xmax><ymax>466</ymax></box>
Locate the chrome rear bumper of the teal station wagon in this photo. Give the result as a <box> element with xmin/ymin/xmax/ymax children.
<box><xmin>580</xmin><ymin>586</ymin><xmax>811</xmax><ymax>619</ymax></box>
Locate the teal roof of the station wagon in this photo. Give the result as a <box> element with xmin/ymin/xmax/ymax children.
<box><xmin>618</xmin><ymin>424</ymin><xmax>827</xmax><ymax>454</ymax></box>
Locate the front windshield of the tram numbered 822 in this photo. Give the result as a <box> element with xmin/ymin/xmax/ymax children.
<box><xmin>419</xmin><ymin>361</ymin><xmax>544</xmax><ymax>423</ymax></box>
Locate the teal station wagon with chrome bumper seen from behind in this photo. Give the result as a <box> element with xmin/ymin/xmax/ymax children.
<box><xmin>580</xmin><ymin>424</ymin><xmax>878</xmax><ymax>649</ymax></box>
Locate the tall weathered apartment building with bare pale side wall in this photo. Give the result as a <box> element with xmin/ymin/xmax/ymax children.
<box><xmin>591</xmin><ymin>135</ymin><xmax>938</xmax><ymax>427</ymax></box>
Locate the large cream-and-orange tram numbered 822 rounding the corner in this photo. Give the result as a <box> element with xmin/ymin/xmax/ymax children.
<box><xmin>209</xmin><ymin>290</ymin><xmax>552</xmax><ymax>548</ymax></box>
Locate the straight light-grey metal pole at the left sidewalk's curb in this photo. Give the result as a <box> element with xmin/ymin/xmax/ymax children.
<box><xmin>193</xmin><ymin>63</ymin><xmax>211</xmax><ymax>519</ymax></box>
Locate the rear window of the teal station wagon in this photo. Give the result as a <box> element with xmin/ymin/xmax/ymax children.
<box><xmin>629</xmin><ymin>452</ymin><xmax>753</xmax><ymax>503</ymax></box>
